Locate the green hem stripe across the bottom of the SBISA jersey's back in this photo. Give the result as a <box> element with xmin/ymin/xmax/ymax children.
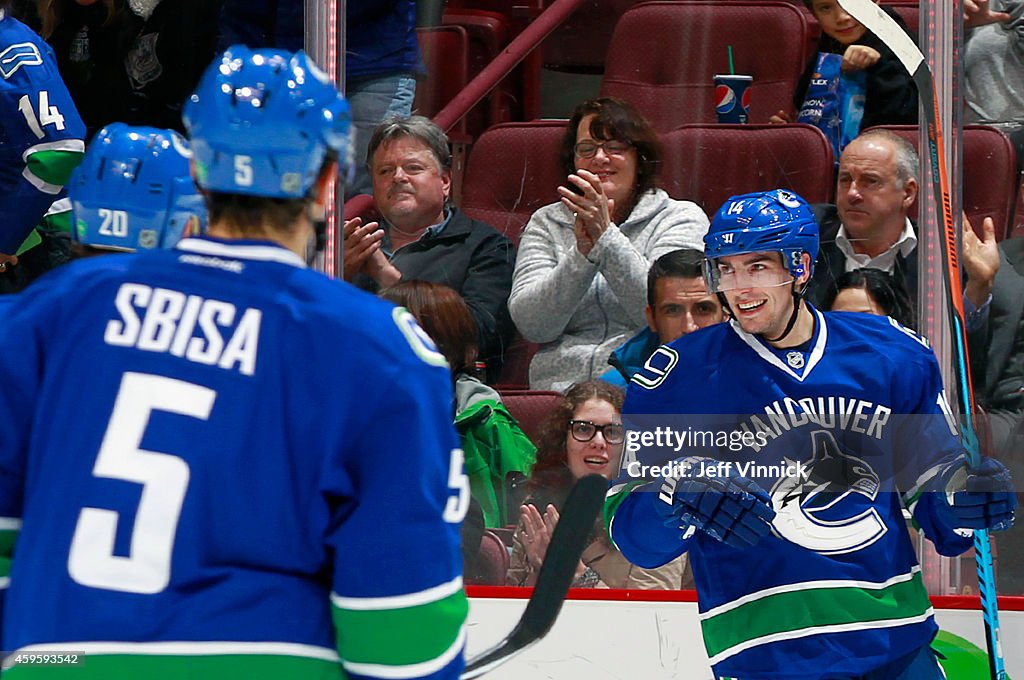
<box><xmin>3</xmin><ymin>643</ymin><xmax>345</xmax><ymax>680</ymax></box>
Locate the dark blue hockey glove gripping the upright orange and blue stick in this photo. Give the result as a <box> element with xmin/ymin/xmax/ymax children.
<box><xmin>935</xmin><ymin>456</ymin><xmax>1017</xmax><ymax>532</ymax></box>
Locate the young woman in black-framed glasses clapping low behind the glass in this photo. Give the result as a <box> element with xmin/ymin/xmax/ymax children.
<box><xmin>508</xmin><ymin>380</ymin><xmax>685</xmax><ymax>589</ymax></box>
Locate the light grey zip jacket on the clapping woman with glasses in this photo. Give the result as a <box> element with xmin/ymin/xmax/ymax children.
<box><xmin>509</xmin><ymin>189</ymin><xmax>709</xmax><ymax>391</ymax></box>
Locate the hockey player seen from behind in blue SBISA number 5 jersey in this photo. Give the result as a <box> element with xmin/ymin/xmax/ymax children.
<box><xmin>0</xmin><ymin>47</ymin><xmax>469</xmax><ymax>680</ymax></box>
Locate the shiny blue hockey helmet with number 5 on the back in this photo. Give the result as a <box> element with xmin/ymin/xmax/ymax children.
<box><xmin>183</xmin><ymin>45</ymin><xmax>351</xmax><ymax>199</ymax></box>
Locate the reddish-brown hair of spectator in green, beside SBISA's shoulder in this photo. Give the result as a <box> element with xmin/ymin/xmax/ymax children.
<box><xmin>380</xmin><ymin>281</ymin><xmax>477</xmax><ymax>376</ymax></box>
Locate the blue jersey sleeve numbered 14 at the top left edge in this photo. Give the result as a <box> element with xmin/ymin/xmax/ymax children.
<box><xmin>0</xmin><ymin>9</ymin><xmax>85</xmax><ymax>254</ymax></box>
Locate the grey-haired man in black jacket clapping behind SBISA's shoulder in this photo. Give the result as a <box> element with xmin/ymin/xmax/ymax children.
<box><xmin>344</xmin><ymin>116</ymin><xmax>515</xmax><ymax>374</ymax></box>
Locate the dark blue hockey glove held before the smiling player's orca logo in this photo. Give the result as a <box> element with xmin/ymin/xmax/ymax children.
<box><xmin>655</xmin><ymin>457</ymin><xmax>775</xmax><ymax>548</ymax></box>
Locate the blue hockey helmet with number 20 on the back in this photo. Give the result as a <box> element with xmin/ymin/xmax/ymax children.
<box><xmin>68</xmin><ymin>123</ymin><xmax>207</xmax><ymax>251</ymax></box>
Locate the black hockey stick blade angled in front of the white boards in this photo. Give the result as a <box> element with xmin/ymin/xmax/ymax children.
<box><xmin>462</xmin><ymin>474</ymin><xmax>608</xmax><ymax>680</ymax></box>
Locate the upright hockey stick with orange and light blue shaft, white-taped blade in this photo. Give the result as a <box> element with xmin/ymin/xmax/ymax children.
<box><xmin>839</xmin><ymin>0</ymin><xmax>1006</xmax><ymax>680</ymax></box>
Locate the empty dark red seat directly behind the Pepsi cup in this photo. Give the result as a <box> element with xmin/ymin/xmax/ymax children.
<box><xmin>601</xmin><ymin>0</ymin><xmax>809</xmax><ymax>132</ymax></box>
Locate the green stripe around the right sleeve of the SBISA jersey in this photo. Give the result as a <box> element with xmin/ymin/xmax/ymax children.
<box><xmin>331</xmin><ymin>588</ymin><xmax>469</xmax><ymax>667</ymax></box>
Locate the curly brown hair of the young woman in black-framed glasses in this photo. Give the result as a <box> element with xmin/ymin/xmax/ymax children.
<box><xmin>526</xmin><ymin>380</ymin><xmax>625</xmax><ymax>501</ymax></box>
